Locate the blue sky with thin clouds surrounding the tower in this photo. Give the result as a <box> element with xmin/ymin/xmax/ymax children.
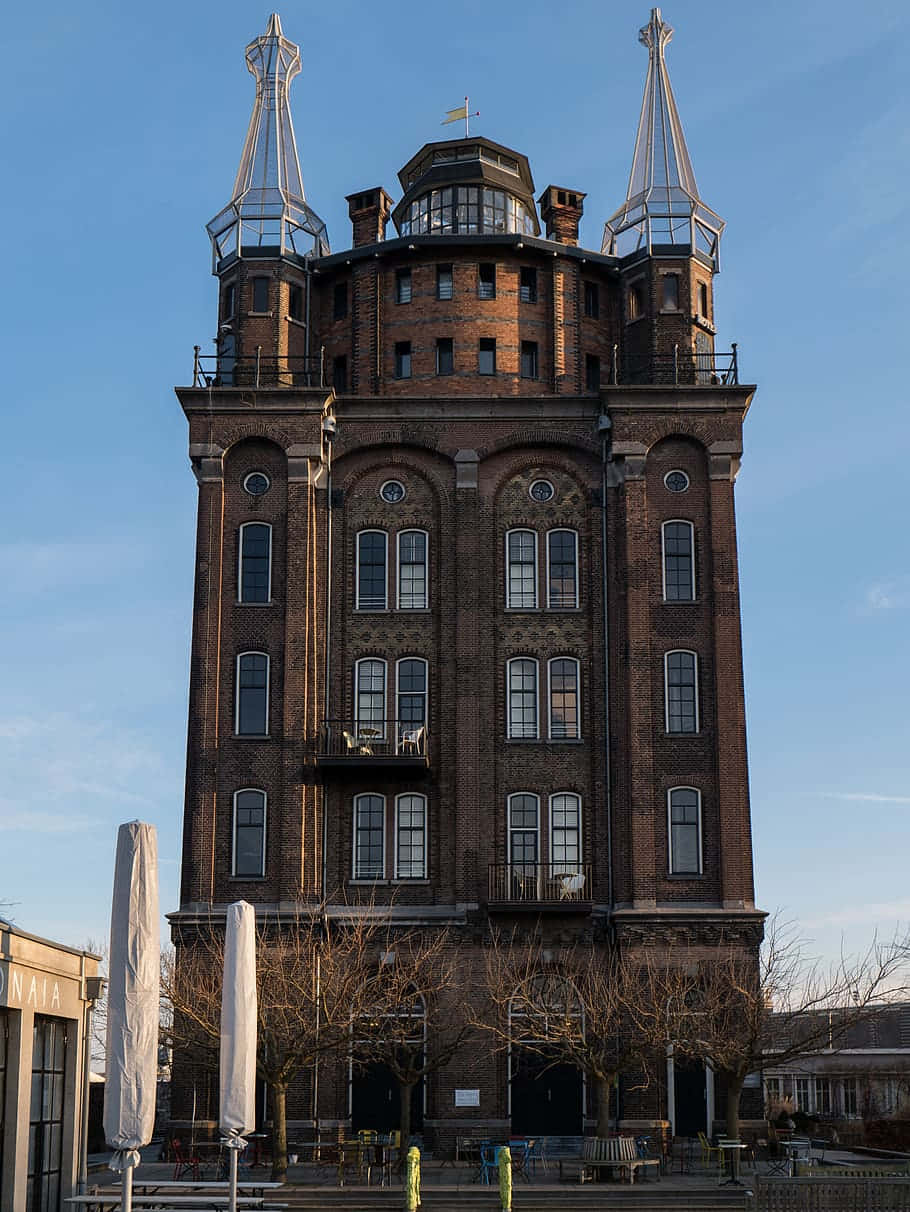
<box><xmin>0</xmin><ymin>0</ymin><xmax>910</xmax><ymax>953</ymax></box>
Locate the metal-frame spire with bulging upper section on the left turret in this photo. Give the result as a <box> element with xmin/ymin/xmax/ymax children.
<box><xmin>206</xmin><ymin>12</ymin><xmax>330</xmax><ymax>267</ymax></box>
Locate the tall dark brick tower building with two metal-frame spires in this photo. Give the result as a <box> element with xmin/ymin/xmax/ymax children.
<box><xmin>171</xmin><ymin>10</ymin><xmax>762</xmax><ymax>1140</ymax></box>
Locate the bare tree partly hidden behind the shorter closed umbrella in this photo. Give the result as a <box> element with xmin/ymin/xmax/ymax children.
<box><xmin>162</xmin><ymin>908</ymin><xmax>382</xmax><ymax>1180</ymax></box>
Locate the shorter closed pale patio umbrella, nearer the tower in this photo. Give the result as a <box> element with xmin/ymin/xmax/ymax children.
<box><xmin>218</xmin><ymin>901</ymin><xmax>257</xmax><ymax>1212</ymax></box>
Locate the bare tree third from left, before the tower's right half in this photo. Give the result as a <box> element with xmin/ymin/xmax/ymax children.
<box><xmin>475</xmin><ymin>938</ymin><xmax>692</xmax><ymax>1137</ymax></box>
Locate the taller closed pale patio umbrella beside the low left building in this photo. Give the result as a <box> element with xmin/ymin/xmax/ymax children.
<box><xmin>104</xmin><ymin>821</ymin><xmax>161</xmax><ymax>1212</ymax></box>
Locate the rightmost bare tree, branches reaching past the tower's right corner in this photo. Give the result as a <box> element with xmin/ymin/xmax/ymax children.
<box><xmin>674</xmin><ymin>919</ymin><xmax>906</xmax><ymax>1139</ymax></box>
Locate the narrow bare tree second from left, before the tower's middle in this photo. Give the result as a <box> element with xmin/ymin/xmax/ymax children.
<box><xmin>351</xmin><ymin>931</ymin><xmax>474</xmax><ymax>1157</ymax></box>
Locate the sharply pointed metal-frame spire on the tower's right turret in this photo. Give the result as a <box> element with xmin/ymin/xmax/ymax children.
<box><xmin>601</xmin><ymin>8</ymin><xmax>725</xmax><ymax>269</ymax></box>
